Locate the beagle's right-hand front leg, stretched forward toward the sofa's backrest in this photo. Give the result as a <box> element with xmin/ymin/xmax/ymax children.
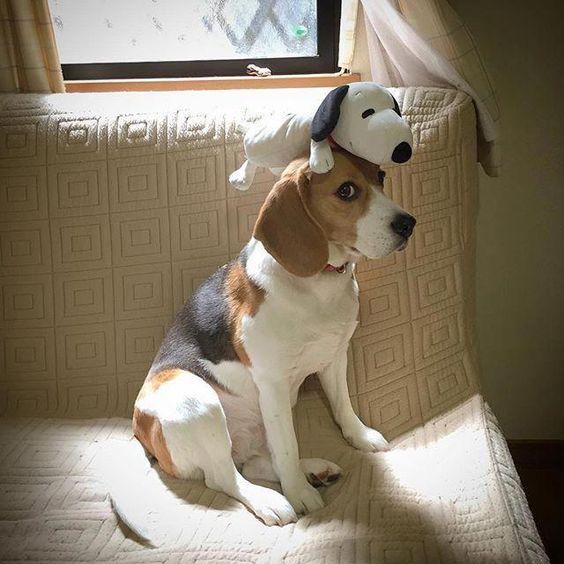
<box><xmin>319</xmin><ymin>351</ymin><xmax>388</xmax><ymax>452</ymax></box>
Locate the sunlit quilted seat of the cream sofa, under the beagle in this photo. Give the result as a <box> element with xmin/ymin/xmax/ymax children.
<box><xmin>0</xmin><ymin>396</ymin><xmax>548</xmax><ymax>564</ymax></box>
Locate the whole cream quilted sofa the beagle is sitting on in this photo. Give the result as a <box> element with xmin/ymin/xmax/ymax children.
<box><xmin>0</xmin><ymin>88</ymin><xmax>547</xmax><ymax>564</ymax></box>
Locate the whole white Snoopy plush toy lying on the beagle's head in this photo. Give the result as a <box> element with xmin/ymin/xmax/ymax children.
<box><xmin>229</xmin><ymin>82</ymin><xmax>413</xmax><ymax>190</ymax></box>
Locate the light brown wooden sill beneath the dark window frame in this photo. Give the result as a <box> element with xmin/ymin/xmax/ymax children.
<box><xmin>65</xmin><ymin>73</ymin><xmax>360</xmax><ymax>92</ymax></box>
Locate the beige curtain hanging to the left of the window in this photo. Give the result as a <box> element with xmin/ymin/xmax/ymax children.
<box><xmin>0</xmin><ymin>0</ymin><xmax>65</xmax><ymax>92</ymax></box>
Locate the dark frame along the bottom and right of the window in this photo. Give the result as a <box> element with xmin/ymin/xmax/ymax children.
<box><xmin>61</xmin><ymin>0</ymin><xmax>341</xmax><ymax>80</ymax></box>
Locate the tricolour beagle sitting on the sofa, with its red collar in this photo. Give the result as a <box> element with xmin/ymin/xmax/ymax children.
<box><xmin>133</xmin><ymin>151</ymin><xmax>415</xmax><ymax>525</ymax></box>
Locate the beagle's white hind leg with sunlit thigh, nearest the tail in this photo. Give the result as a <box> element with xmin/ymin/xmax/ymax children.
<box><xmin>143</xmin><ymin>372</ymin><xmax>296</xmax><ymax>525</ymax></box>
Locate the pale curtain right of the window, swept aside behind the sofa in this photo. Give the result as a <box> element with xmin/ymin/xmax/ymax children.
<box><xmin>339</xmin><ymin>0</ymin><xmax>500</xmax><ymax>176</ymax></box>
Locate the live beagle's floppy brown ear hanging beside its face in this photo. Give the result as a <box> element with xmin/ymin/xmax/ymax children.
<box><xmin>253</xmin><ymin>165</ymin><xmax>329</xmax><ymax>277</ymax></box>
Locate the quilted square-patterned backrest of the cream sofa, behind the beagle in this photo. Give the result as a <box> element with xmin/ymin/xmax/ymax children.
<box><xmin>0</xmin><ymin>88</ymin><xmax>478</xmax><ymax>438</ymax></box>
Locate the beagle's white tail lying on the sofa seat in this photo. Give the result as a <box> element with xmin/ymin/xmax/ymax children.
<box><xmin>96</xmin><ymin>437</ymin><xmax>159</xmax><ymax>546</ymax></box>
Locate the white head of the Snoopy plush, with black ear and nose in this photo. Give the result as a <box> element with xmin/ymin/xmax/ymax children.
<box><xmin>311</xmin><ymin>82</ymin><xmax>413</xmax><ymax>165</ymax></box>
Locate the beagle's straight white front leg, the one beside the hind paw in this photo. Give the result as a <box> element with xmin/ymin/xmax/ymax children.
<box><xmin>254</xmin><ymin>375</ymin><xmax>324</xmax><ymax>513</ymax></box>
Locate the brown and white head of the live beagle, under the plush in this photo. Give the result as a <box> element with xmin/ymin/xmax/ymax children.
<box><xmin>254</xmin><ymin>151</ymin><xmax>415</xmax><ymax>277</ymax></box>
